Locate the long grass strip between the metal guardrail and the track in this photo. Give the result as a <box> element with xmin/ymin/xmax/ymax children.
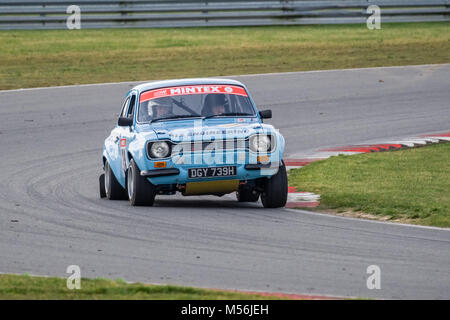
<box><xmin>0</xmin><ymin>22</ymin><xmax>450</xmax><ymax>89</ymax></box>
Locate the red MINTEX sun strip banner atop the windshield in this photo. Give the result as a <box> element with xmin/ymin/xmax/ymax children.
<box><xmin>141</xmin><ymin>85</ymin><xmax>247</xmax><ymax>102</ymax></box>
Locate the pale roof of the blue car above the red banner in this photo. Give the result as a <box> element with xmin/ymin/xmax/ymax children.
<box><xmin>131</xmin><ymin>78</ymin><xmax>245</xmax><ymax>92</ymax></box>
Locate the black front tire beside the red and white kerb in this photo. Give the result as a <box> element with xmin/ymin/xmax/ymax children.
<box><xmin>261</xmin><ymin>162</ymin><xmax>288</xmax><ymax>208</ymax></box>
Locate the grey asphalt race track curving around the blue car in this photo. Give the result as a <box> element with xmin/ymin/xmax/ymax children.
<box><xmin>0</xmin><ymin>65</ymin><xmax>450</xmax><ymax>299</ymax></box>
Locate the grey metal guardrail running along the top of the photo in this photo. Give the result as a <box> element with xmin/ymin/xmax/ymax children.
<box><xmin>0</xmin><ymin>0</ymin><xmax>450</xmax><ymax>30</ymax></box>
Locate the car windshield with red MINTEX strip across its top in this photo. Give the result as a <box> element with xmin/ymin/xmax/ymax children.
<box><xmin>138</xmin><ymin>85</ymin><xmax>255</xmax><ymax>123</ymax></box>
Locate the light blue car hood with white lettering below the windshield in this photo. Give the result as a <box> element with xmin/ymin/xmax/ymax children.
<box><xmin>135</xmin><ymin>118</ymin><xmax>274</xmax><ymax>142</ymax></box>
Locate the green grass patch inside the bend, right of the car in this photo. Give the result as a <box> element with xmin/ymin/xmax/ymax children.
<box><xmin>289</xmin><ymin>143</ymin><xmax>450</xmax><ymax>227</ymax></box>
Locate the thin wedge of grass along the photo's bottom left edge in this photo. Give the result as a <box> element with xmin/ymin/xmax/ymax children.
<box><xmin>0</xmin><ymin>274</ymin><xmax>280</xmax><ymax>300</ymax></box>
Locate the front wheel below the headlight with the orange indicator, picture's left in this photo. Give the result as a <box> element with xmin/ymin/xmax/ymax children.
<box><xmin>127</xmin><ymin>159</ymin><xmax>156</xmax><ymax>206</ymax></box>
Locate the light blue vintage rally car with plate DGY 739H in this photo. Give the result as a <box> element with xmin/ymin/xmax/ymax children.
<box><xmin>100</xmin><ymin>79</ymin><xmax>288</xmax><ymax>208</ymax></box>
